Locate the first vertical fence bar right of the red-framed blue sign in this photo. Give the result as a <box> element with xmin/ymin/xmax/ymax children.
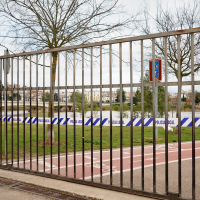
<box><xmin>164</xmin><ymin>37</ymin><xmax>169</xmax><ymax>195</ymax></box>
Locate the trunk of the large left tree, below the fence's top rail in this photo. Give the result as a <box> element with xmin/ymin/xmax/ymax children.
<box><xmin>46</xmin><ymin>52</ymin><xmax>59</xmax><ymax>145</ymax></box>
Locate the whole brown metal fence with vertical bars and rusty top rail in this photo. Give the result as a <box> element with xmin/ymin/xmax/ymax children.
<box><xmin>0</xmin><ymin>28</ymin><xmax>200</xmax><ymax>199</ymax></box>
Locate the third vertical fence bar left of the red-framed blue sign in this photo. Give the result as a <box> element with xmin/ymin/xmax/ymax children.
<box><xmin>119</xmin><ymin>43</ymin><xmax>123</xmax><ymax>187</ymax></box>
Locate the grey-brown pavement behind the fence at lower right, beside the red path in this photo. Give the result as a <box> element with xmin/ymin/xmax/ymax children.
<box><xmin>94</xmin><ymin>158</ymin><xmax>200</xmax><ymax>200</ymax></box>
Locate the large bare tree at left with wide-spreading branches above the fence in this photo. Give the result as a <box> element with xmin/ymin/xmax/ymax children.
<box><xmin>0</xmin><ymin>0</ymin><xmax>134</xmax><ymax>143</ymax></box>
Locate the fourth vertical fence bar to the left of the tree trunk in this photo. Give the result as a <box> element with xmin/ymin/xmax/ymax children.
<box><xmin>23</xmin><ymin>56</ymin><xmax>26</xmax><ymax>169</ymax></box>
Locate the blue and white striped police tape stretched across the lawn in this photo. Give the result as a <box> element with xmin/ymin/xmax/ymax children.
<box><xmin>3</xmin><ymin>117</ymin><xmax>200</xmax><ymax>127</ymax></box>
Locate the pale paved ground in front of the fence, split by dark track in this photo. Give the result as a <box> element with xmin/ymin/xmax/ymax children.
<box><xmin>0</xmin><ymin>169</ymin><xmax>150</xmax><ymax>200</ymax></box>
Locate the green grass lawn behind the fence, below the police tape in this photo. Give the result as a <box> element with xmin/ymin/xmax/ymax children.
<box><xmin>2</xmin><ymin>123</ymin><xmax>200</xmax><ymax>158</ymax></box>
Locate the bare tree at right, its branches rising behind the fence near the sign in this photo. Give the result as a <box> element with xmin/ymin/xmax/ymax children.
<box><xmin>135</xmin><ymin>0</ymin><xmax>200</xmax><ymax>122</ymax></box>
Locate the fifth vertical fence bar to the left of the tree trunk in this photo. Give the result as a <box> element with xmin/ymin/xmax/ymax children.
<box><xmin>17</xmin><ymin>57</ymin><xmax>19</xmax><ymax>168</ymax></box>
